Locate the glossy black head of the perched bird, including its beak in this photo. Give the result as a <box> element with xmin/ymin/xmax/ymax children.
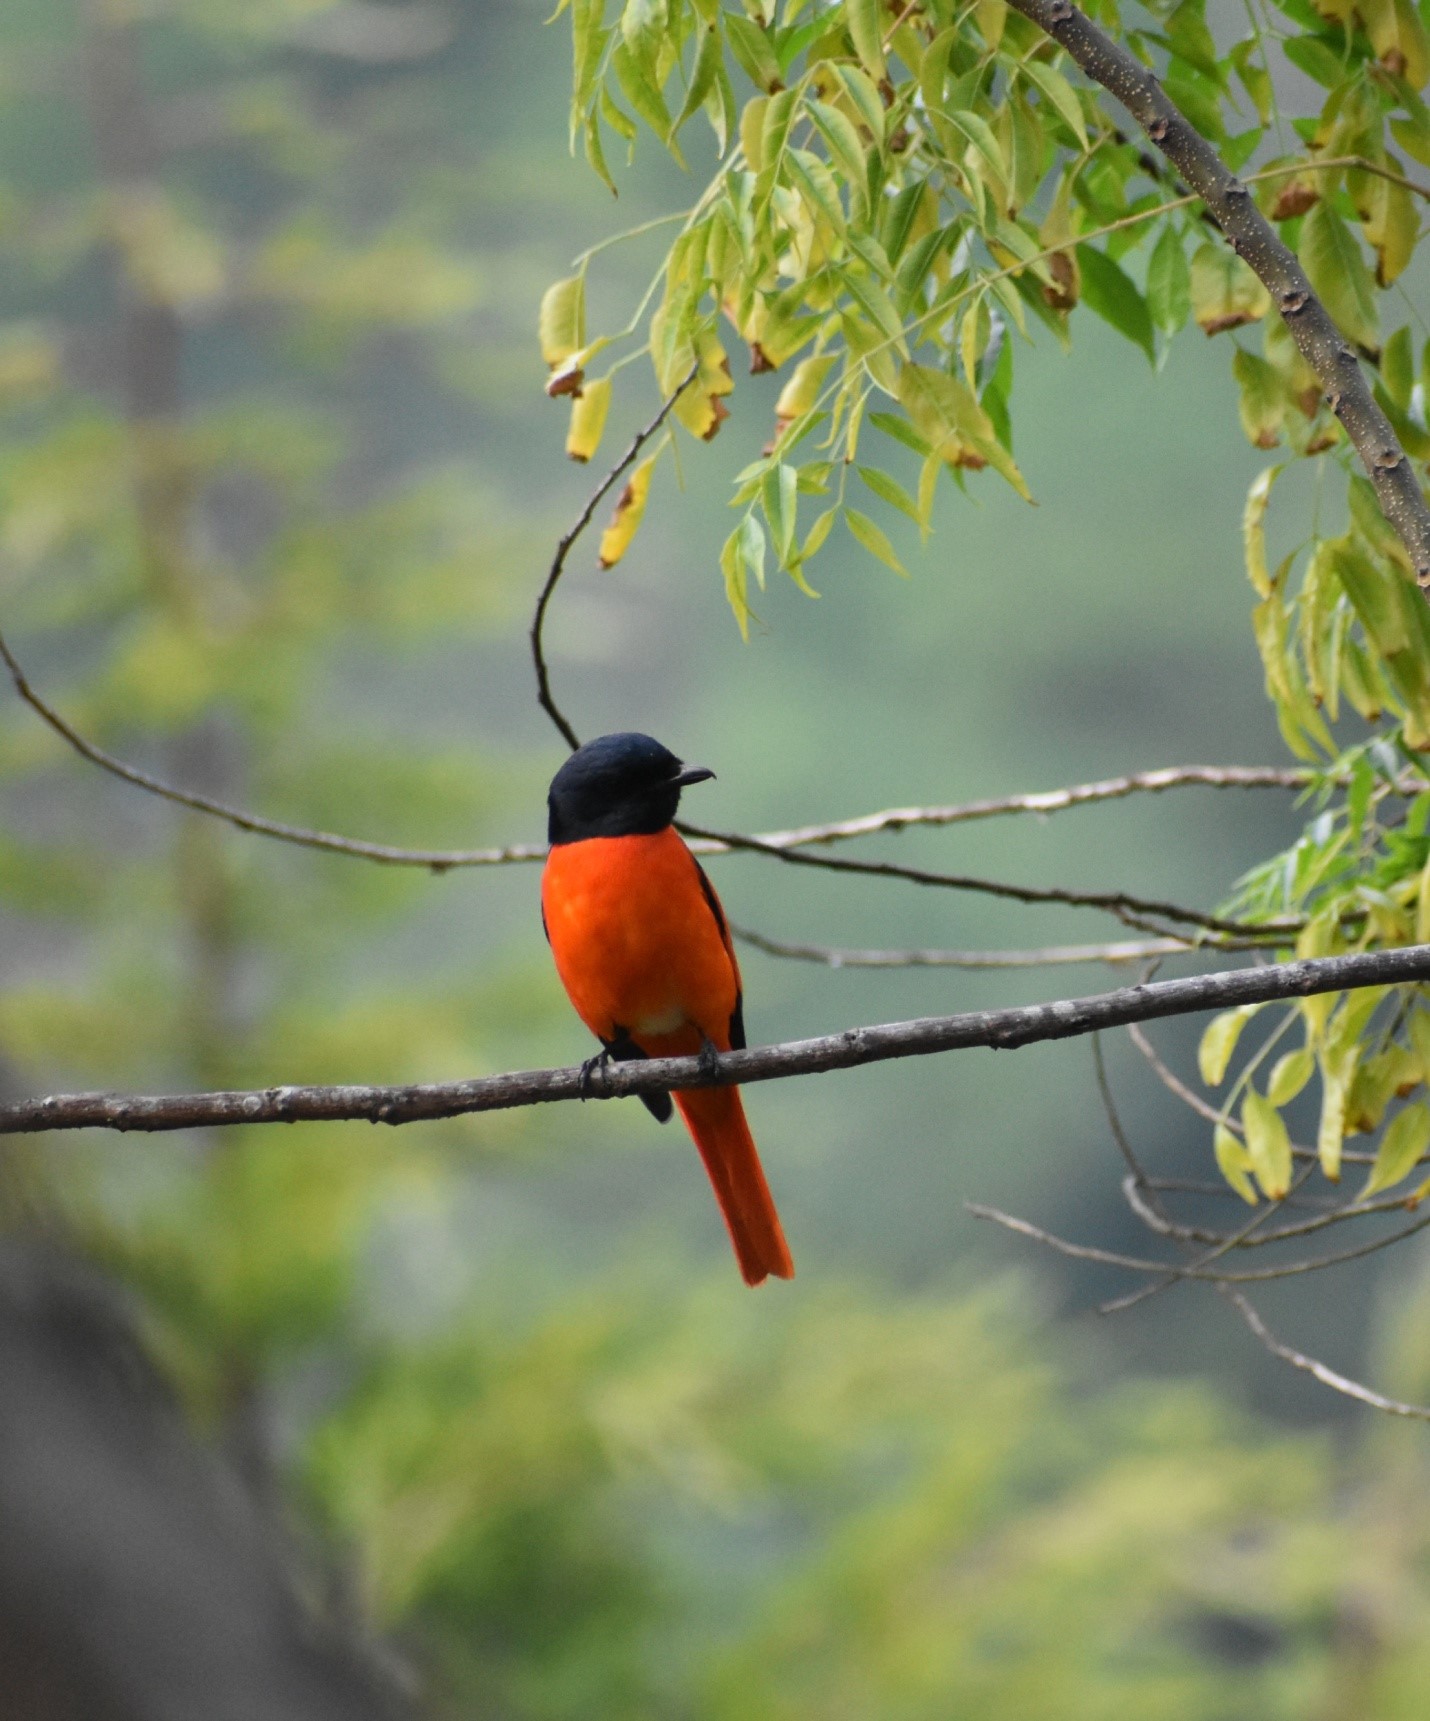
<box><xmin>545</xmin><ymin>733</ymin><xmax>714</xmax><ymax>843</ymax></box>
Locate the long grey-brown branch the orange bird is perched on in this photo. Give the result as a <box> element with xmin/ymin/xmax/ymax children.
<box><xmin>0</xmin><ymin>945</ymin><xmax>1430</xmax><ymax>1134</ymax></box>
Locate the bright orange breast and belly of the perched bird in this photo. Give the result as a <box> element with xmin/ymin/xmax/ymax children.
<box><xmin>542</xmin><ymin>830</ymin><xmax>740</xmax><ymax>1055</ymax></box>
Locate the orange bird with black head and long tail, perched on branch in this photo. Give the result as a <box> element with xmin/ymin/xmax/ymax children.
<box><xmin>542</xmin><ymin>731</ymin><xmax>795</xmax><ymax>1286</ymax></box>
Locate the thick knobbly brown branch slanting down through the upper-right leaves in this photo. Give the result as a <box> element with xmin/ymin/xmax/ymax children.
<box><xmin>1010</xmin><ymin>0</ymin><xmax>1430</xmax><ymax>587</ymax></box>
